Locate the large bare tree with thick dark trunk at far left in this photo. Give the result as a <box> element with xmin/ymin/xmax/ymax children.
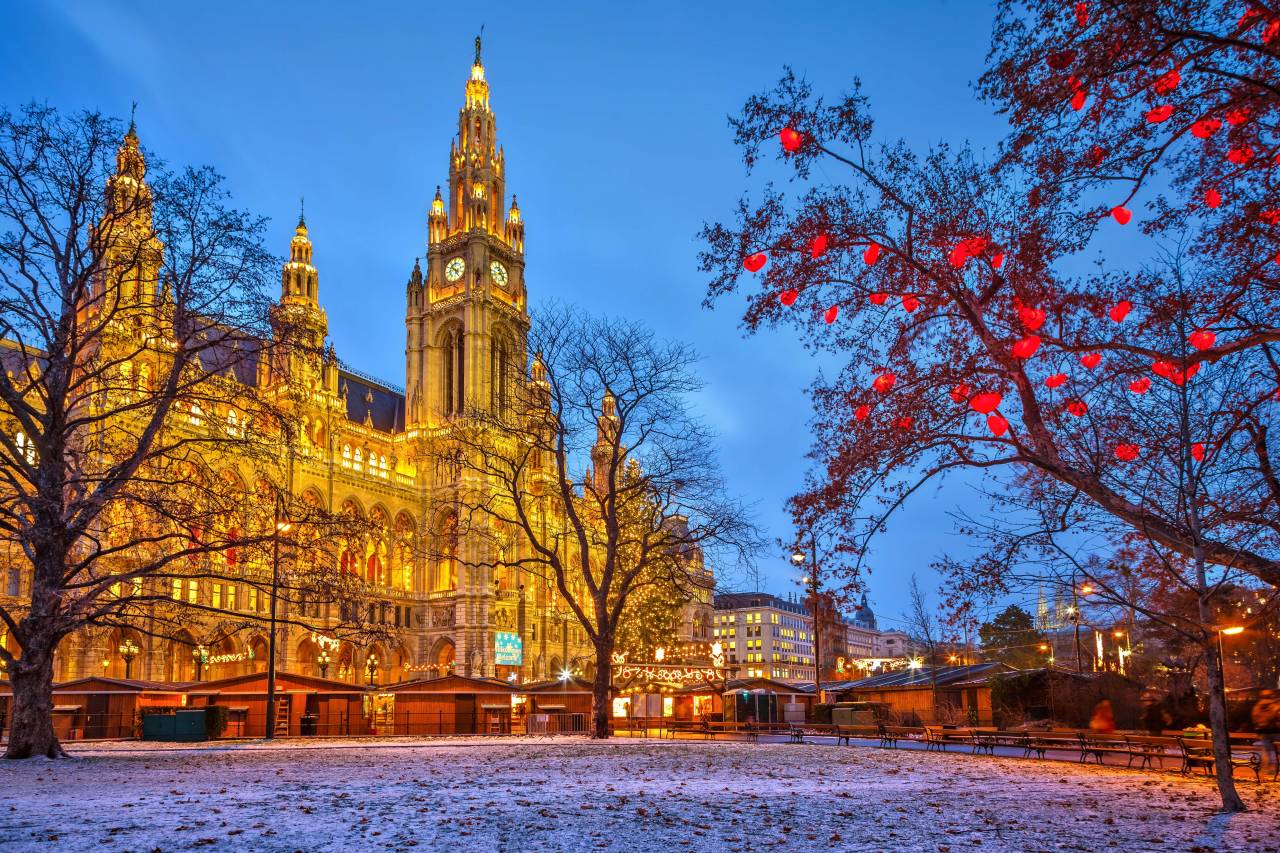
<box><xmin>0</xmin><ymin>106</ymin><xmax>371</xmax><ymax>758</ymax></box>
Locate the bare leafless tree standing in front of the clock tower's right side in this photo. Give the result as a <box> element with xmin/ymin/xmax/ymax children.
<box><xmin>440</xmin><ymin>307</ymin><xmax>758</xmax><ymax>738</ymax></box>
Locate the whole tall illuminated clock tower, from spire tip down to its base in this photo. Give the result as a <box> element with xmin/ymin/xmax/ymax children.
<box><xmin>404</xmin><ymin>38</ymin><xmax>529</xmax><ymax>675</ymax></box>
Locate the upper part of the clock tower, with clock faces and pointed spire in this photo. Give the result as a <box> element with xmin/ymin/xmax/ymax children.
<box><xmin>404</xmin><ymin>38</ymin><xmax>529</xmax><ymax>429</ymax></box>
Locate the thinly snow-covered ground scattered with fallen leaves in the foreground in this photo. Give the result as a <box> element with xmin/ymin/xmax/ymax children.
<box><xmin>0</xmin><ymin>739</ymin><xmax>1280</xmax><ymax>853</ymax></box>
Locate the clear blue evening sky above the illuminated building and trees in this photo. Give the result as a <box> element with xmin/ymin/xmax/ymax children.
<box><xmin>0</xmin><ymin>0</ymin><xmax>1049</xmax><ymax>617</ymax></box>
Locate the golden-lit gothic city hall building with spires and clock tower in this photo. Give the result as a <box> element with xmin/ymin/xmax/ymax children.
<box><xmin>0</xmin><ymin>40</ymin><xmax>629</xmax><ymax>684</ymax></box>
